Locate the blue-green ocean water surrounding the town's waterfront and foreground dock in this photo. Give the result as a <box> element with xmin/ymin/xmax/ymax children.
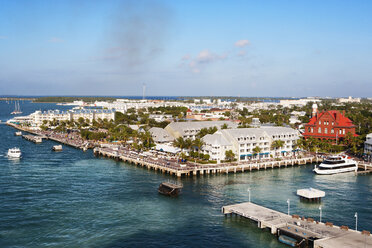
<box><xmin>0</xmin><ymin>101</ymin><xmax>372</xmax><ymax>247</ymax></box>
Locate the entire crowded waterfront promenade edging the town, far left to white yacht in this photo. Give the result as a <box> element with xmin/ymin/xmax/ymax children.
<box><xmin>7</xmin><ymin>123</ymin><xmax>372</xmax><ymax>177</ymax></box>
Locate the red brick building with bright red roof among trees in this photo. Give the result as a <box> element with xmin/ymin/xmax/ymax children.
<box><xmin>303</xmin><ymin>110</ymin><xmax>358</xmax><ymax>139</ymax></box>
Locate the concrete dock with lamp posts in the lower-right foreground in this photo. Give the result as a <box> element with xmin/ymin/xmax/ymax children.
<box><xmin>222</xmin><ymin>202</ymin><xmax>372</xmax><ymax>248</ymax></box>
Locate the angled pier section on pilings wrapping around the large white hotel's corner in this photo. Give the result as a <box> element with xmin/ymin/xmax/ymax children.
<box><xmin>93</xmin><ymin>147</ymin><xmax>319</xmax><ymax>177</ymax></box>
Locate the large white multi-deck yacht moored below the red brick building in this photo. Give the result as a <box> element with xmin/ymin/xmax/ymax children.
<box><xmin>314</xmin><ymin>155</ymin><xmax>358</xmax><ymax>175</ymax></box>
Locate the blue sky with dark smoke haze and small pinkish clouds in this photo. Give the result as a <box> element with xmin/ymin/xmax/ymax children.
<box><xmin>0</xmin><ymin>0</ymin><xmax>372</xmax><ymax>97</ymax></box>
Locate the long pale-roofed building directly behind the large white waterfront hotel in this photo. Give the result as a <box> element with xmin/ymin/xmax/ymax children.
<box><xmin>165</xmin><ymin>121</ymin><xmax>238</xmax><ymax>139</ymax></box>
